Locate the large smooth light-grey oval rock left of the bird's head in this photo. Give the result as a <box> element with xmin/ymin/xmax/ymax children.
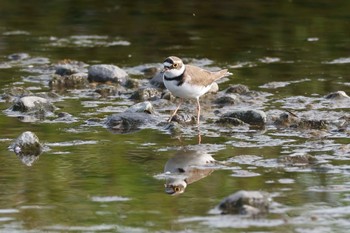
<box><xmin>88</xmin><ymin>65</ymin><xmax>128</xmax><ymax>83</ymax></box>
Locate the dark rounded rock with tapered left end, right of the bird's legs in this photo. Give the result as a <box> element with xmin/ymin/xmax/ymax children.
<box><xmin>223</xmin><ymin>110</ymin><xmax>266</xmax><ymax>126</ymax></box>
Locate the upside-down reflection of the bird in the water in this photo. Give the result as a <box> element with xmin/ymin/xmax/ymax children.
<box><xmin>164</xmin><ymin>150</ymin><xmax>216</xmax><ymax>194</ymax></box>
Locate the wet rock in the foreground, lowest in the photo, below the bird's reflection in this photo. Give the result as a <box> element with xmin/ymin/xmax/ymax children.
<box><xmin>218</xmin><ymin>190</ymin><xmax>271</xmax><ymax>216</ymax></box>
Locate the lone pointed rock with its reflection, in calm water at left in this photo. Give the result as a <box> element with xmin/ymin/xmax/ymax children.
<box><xmin>10</xmin><ymin>131</ymin><xmax>43</xmax><ymax>166</ymax></box>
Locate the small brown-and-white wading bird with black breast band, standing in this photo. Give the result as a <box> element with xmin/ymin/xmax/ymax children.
<box><xmin>162</xmin><ymin>56</ymin><xmax>231</xmax><ymax>125</ymax></box>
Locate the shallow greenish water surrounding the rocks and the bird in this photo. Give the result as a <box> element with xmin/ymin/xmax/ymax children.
<box><xmin>0</xmin><ymin>0</ymin><xmax>350</xmax><ymax>232</ymax></box>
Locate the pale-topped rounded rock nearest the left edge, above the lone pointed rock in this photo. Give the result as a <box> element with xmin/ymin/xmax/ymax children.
<box><xmin>12</xmin><ymin>96</ymin><xmax>55</xmax><ymax>112</ymax></box>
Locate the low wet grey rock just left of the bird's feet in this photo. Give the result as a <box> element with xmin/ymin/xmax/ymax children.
<box><xmin>105</xmin><ymin>112</ymin><xmax>157</xmax><ymax>133</ymax></box>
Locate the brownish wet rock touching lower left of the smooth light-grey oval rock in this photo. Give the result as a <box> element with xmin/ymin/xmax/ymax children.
<box><xmin>49</xmin><ymin>73</ymin><xmax>89</xmax><ymax>89</ymax></box>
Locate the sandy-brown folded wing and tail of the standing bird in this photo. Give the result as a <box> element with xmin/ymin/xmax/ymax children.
<box><xmin>184</xmin><ymin>65</ymin><xmax>230</xmax><ymax>86</ymax></box>
